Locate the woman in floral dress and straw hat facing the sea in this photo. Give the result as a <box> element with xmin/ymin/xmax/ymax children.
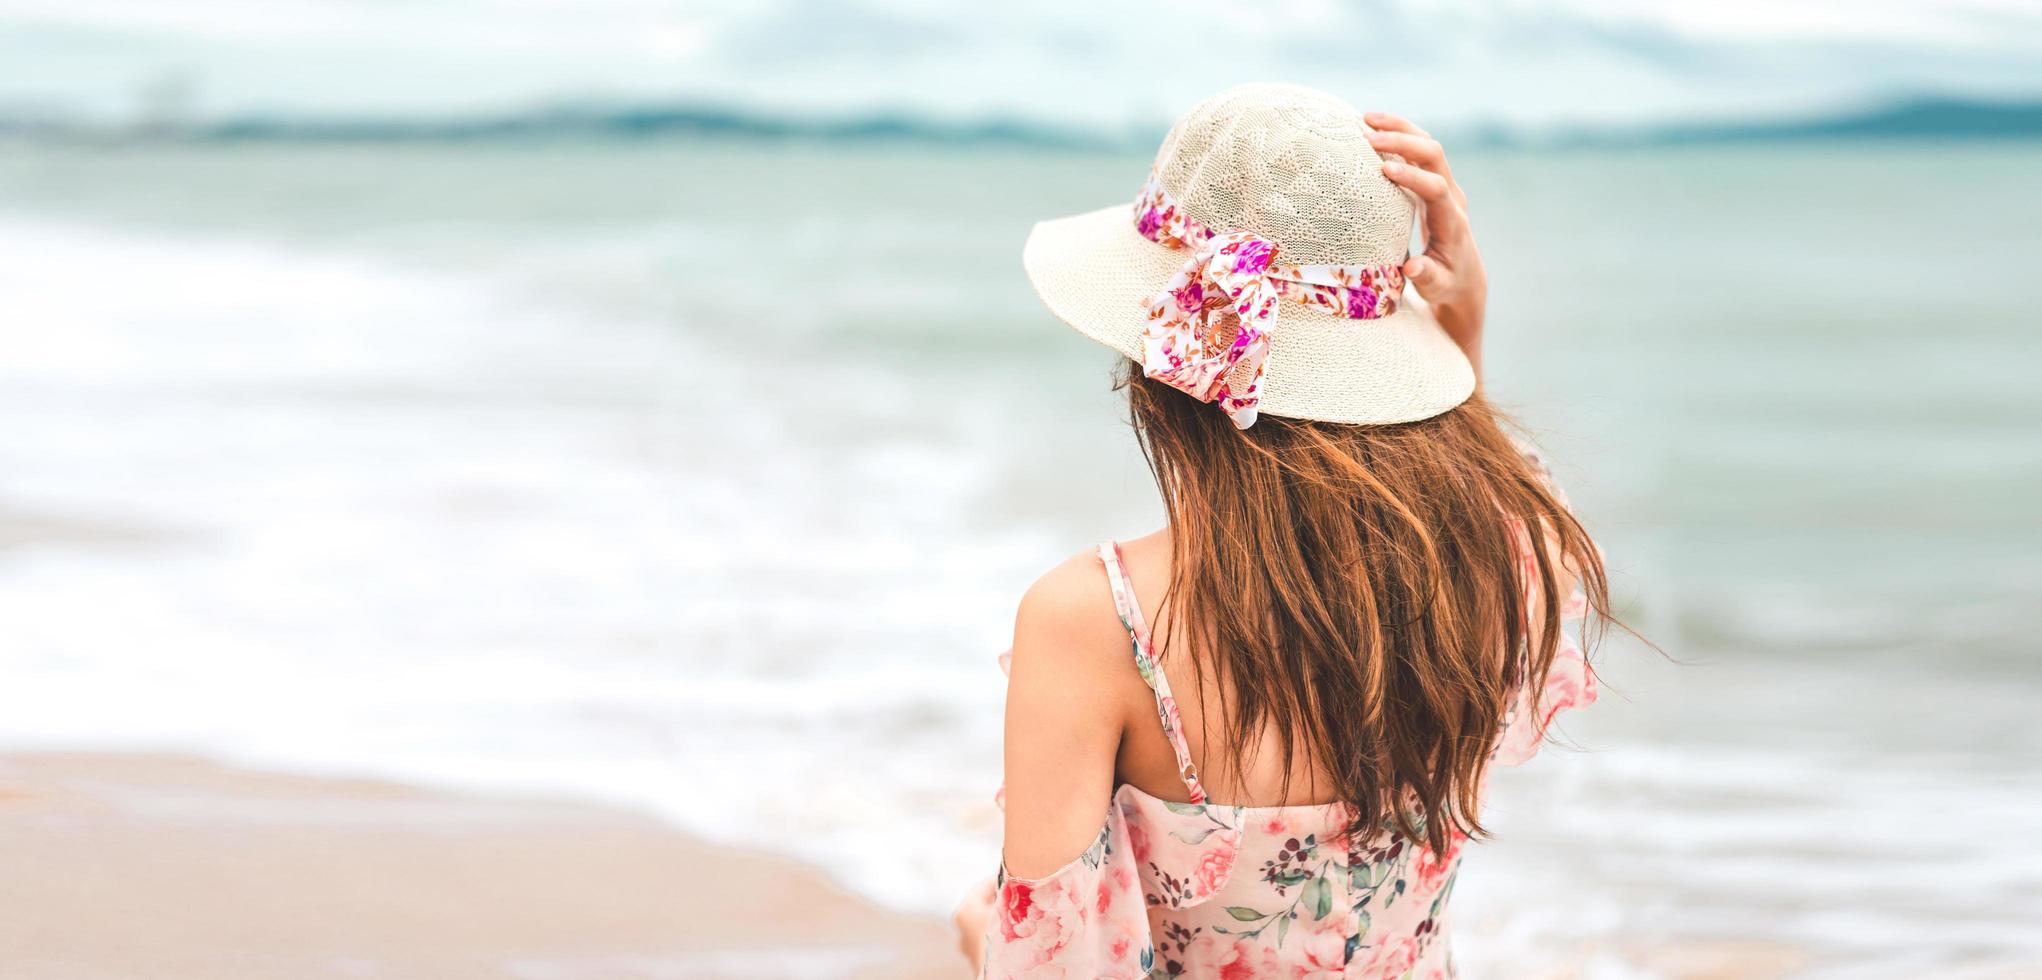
<box><xmin>958</xmin><ymin>86</ymin><xmax>1607</xmax><ymax>980</ymax></box>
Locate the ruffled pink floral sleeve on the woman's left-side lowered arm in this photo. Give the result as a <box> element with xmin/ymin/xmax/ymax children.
<box><xmin>978</xmin><ymin>819</ymin><xmax>1156</xmax><ymax>980</ymax></box>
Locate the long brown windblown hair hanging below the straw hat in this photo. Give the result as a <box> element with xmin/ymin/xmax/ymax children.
<box><xmin>1121</xmin><ymin>361</ymin><xmax>1609</xmax><ymax>851</ymax></box>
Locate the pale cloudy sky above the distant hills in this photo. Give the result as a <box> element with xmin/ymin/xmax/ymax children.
<box><xmin>0</xmin><ymin>0</ymin><xmax>2042</xmax><ymax>127</ymax></box>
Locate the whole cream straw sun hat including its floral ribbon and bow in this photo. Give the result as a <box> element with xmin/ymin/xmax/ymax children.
<box><xmin>1023</xmin><ymin>86</ymin><xmax>1474</xmax><ymax>429</ymax></box>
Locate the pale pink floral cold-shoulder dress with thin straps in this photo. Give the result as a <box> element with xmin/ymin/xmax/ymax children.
<box><xmin>982</xmin><ymin>526</ymin><xmax>1595</xmax><ymax>980</ymax></box>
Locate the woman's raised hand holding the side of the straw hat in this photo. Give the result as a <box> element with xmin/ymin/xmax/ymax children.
<box><xmin>1362</xmin><ymin>112</ymin><xmax>1489</xmax><ymax>378</ymax></box>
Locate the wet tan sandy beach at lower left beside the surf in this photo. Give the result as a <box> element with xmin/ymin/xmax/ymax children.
<box><xmin>0</xmin><ymin>753</ymin><xmax>964</xmax><ymax>980</ymax></box>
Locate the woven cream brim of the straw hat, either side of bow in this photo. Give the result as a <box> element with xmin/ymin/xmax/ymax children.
<box><xmin>1021</xmin><ymin>204</ymin><xmax>1474</xmax><ymax>425</ymax></box>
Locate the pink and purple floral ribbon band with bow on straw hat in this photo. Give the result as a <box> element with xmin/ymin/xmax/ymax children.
<box><xmin>1135</xmin><ymin>176</ymin><xmax>1403</xmax><ymax>429</ymax></box>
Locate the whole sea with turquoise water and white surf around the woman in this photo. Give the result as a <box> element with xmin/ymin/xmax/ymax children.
<box><xmin>0</xmin><ymin>143</ymin><xmax>2042</xmax><ymax>976</ymax></box>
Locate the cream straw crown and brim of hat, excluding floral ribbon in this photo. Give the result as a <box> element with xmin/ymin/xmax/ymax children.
<box><xmin>1021</xmin><ymin>84</ymin><xmax>1474</xmax><ymax>427</ymax></box>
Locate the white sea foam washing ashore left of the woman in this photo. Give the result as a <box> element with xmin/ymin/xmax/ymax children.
<box><xmin>0</xmin><ymin>212</ymin><xmax>1009</xmax><ymax>907</ymax></box>
